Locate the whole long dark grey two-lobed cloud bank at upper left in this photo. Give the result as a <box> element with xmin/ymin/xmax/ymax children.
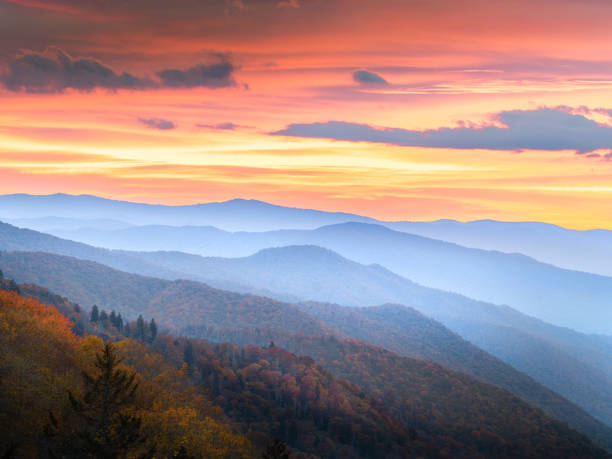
<box><xmin>0</xmin><ymin>46</ymin><xmax>236</xmax><ymax>93</ymax></box>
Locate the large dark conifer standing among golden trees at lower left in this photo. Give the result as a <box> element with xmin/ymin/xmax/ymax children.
<box><xmin>69</xmin><ymin>343</ymin><xmax>146</xmax><ymax>459</ymax></box>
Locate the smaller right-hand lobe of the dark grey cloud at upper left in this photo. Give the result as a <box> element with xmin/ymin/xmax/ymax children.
<box><xmin>157</xmin><ymin>54</ymin><xmax>236</xmax><ymax>88</ymax></box>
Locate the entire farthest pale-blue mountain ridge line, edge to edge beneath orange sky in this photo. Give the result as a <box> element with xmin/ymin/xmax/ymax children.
<box><xmin>0</xmin><ymin>193</ymin><xmax>612</xmax><ymax>276</ymax></box>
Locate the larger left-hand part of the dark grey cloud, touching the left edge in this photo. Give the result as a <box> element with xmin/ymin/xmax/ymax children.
<box><xmin>0</xmin><ymin>47</ymin><xmax>154</xmax><ymax>93</ymax></box>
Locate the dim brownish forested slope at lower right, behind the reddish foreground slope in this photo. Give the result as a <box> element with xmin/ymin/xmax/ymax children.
<box><xmin>201</xmin><ymin>330</ymin><xmax>608</xmax><ymax>457</ymax></box>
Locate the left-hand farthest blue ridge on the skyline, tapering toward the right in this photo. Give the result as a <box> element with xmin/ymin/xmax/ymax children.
<box><xmin>0</xmin><ymin>193</ymin><xmax>375</xmax><ymax>231</ymax></box>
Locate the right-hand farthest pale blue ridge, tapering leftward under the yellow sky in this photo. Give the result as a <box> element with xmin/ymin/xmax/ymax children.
<box><xmin>385</xmin><ymin>220</ymin><xmax>612</xmax><ymax>276</ymax></box>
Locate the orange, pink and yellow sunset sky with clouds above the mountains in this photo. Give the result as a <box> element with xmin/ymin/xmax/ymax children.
<box><xmin>0</xmin><ymin>0</ymin><xmax>612</xmax><ymax>229</ymax></box>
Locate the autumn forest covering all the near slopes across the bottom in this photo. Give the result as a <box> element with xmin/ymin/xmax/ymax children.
<box><xmin>0</xmin><ymin>274</ymin><xmax>607</xmax><ymax>458</ymax></box>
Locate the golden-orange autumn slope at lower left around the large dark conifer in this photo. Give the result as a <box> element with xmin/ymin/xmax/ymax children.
<box><xmin>0</xmin><ymin>291</ymin><xmax>253</xmax><ymax>459</ymax></box>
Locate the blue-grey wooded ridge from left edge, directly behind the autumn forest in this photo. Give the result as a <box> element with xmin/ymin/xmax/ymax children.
<box><xmin>0</xmin><ymin>252</ymin><xmax>337</xmax><ymax>335</ymax></box>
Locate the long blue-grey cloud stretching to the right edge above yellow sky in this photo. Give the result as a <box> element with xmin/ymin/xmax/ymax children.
<box><xmin>271</xmin><ymin>108</ymin><xmax>612</xmax><ymax>154</ymax></box>
